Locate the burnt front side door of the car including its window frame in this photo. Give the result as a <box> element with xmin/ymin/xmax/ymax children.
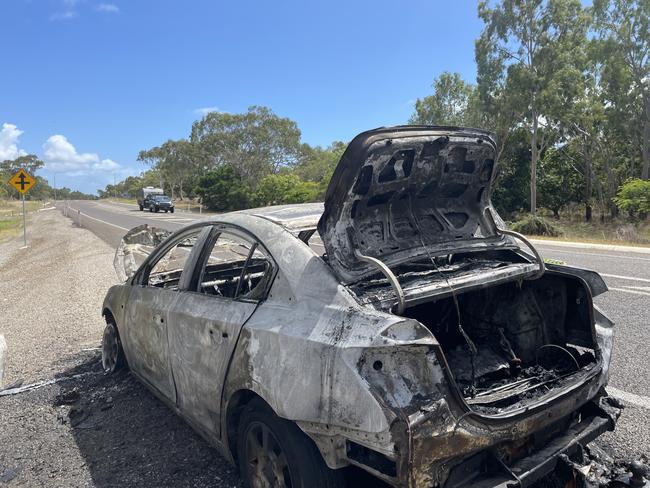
<box><xmin>122</xmin><ymin>222</ymin><xmax>212</xmax><ymax>404</ymax></box>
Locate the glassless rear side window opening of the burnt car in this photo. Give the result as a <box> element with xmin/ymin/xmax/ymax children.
<box><xmin>198</xmin><ymin>232</ymin><xmax>273</xmax><ymax>300</ymax></box>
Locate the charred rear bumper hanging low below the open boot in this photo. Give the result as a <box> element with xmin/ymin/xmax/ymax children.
<box><xmin>444</xmin><ymin>396</ymin><xmax>621</xmax><ymax>488</ymax></box>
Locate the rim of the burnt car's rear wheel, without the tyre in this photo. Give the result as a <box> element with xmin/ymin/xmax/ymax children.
<box><xmin>246</xmin><ymin>422</ymin><xmax>293</xmax><ymax>488</ymax></box>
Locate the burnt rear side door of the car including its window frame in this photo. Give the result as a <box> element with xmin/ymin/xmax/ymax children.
<box><xmin>168</xmin><ymin>223</ymin><xmax>279</xmax><ymax>438</ymax></box>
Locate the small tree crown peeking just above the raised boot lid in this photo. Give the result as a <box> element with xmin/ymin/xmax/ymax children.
<box><xmin>409</xmin><ymin>71</ymin><xmax>478</xmax><ymax>126</ymax></box>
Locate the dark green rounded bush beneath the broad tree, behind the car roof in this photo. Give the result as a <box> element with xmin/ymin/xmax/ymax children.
<box><xmin>195</xmin><ymin>166</ymin><xmax>251</xmax><ymax>212</ymax></box>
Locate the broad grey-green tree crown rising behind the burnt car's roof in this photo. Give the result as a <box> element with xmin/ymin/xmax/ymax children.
<box><xmin>190</xmin><ymin>106</ymin><xmax>301</xmax><ymax>188</ymax></box>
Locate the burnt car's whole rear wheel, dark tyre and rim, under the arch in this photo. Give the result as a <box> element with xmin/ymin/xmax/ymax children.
<box><xmin>237</xmin><ymin>402</ymin><xmax>343</xmax><ymax>488</ymax></box>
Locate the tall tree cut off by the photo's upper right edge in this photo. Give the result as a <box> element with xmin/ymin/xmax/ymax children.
<box><xmin>593</xmin><ymin>0</ymin><xmax>650</xmax><ymax>180</ymax></box>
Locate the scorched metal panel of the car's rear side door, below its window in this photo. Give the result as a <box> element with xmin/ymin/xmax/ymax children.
<box><xmin>168</xmin><ymin>292</ymin><xmax>257</xmax><ymax>435</ymax></box>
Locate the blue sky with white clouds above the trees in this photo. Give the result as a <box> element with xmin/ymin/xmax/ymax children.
<box><xmin>0</xmin><ymin>0</ymin><xmax>482</xmax><ymax>192</ymax></box>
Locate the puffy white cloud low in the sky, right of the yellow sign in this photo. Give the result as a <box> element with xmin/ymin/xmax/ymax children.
<box><xmin>43</xmin><ymin>134</ymin><xmax>120</xmax><ymax>175</ymax></box>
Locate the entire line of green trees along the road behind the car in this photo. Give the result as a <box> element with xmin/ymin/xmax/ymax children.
<box><xmin>100</xmin><ymin>0</ymin><xmax>650</xmax><ymax>217</ymax></box>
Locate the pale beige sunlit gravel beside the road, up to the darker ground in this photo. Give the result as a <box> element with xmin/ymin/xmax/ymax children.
<box><xmin>0</xmin><ymin>210</ymin><xmax>117</xmax><ymax>386</ymax></box>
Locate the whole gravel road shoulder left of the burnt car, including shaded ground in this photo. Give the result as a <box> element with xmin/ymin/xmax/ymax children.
<box><xmin>0</xmin><ymin>211</ymin><xmax>239</xmax><ymax>487</ymax></box>
